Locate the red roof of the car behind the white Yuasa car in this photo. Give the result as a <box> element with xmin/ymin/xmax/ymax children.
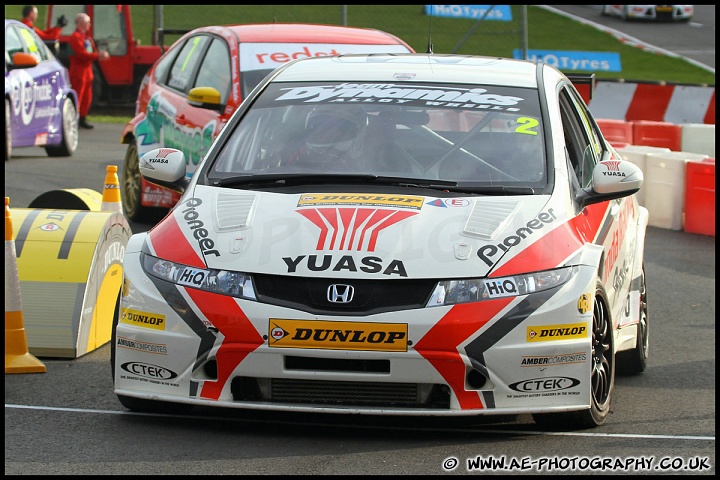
<box><xmin>188</xmin><ymin>23</ymin><xmax>409</xmax><ymax>48</ymax></box>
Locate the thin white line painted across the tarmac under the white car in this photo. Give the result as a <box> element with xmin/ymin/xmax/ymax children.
<box><xmin>5</xmin><ymin>403</ymin><xmax>715</xmax><ymax>442</ymax></box>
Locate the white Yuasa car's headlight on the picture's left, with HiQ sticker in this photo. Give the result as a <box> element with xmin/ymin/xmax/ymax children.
<box><xmin>141</xmin><ymin>253</ymin><xmax>257</xmax><ymax>300</ymax></box>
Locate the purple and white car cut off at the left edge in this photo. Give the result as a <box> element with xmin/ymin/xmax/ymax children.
<box><xmin>5</xmin><ymin>19</ymin><xmax>78</xmax><ymax>160</ymax></box>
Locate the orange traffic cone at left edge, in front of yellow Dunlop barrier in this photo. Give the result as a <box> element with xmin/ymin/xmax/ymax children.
<box><xmin>5</xmin><ymin>197</ymin><xmax>47</xmax><ymax>374</ymax></box>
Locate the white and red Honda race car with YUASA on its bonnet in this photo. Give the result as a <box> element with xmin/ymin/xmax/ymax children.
<box><xmin>111</xmin><ymin>54</ymin><xmax>648</xmax><ymax>429</ymax></box>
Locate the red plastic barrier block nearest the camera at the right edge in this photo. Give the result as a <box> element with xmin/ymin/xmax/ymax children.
<box><xmin>684</xmin><ymin>158</ymin><xmax>715</xmax><ymax>237</ymax></box>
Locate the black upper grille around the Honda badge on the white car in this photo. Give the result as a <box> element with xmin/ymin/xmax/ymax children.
<box><xmin>253</xmin><ymin>274</ymin><xmax>437</xmax><ymax>315</ymax></box>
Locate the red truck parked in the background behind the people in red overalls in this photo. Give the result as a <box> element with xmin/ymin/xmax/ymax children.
<box><xmin>46</xmin><ymin>5</ymin><xmax>163</xmax><ymax>105</ymax></box>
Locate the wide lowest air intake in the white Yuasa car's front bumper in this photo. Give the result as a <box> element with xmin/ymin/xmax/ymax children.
<box><xmin>231</xmin><ymin>377</ymin><xmax>450</xmax><ymax>410</ymax></box>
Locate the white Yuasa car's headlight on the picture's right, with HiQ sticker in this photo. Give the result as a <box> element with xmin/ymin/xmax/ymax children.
<box><xmin>426</xmin><ymin>267</ymin><xmax>575</xmax><ymax>307</ymax></box>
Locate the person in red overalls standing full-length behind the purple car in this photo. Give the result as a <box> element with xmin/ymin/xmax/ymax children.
<box><xmin>68</xmin><ymin>13</ymin><xmax>110</xmax><ymax>129</ymax></box>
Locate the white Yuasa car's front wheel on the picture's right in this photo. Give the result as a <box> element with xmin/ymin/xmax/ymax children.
<box><xmin>533</xmin><ymin>280</ymin><xmax>615</xmax><ymax>430</ymax></box>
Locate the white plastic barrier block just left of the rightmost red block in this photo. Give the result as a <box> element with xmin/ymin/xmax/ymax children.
<box><xmin>643</xmin><ymin>152</ymin><xmax>708</xmax><ymax>230</ymax></box>
